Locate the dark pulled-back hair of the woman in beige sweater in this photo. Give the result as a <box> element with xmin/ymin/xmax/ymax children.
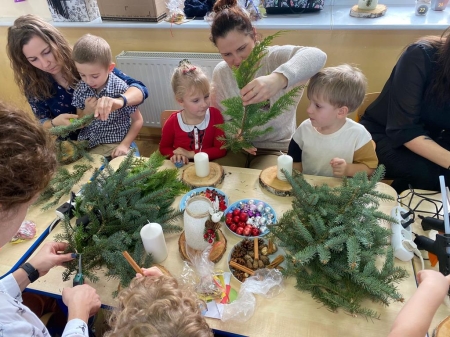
<box><xmin>209</xmin><ymin>0</ymin><xmax>256</xmax><ymax>45</ymax></box>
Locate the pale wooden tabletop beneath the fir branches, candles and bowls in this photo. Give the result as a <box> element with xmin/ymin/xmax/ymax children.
<box><xmin>23</xmin><ymin>161</ymin><xmax>416</xmax><ymax>337</ymax></box>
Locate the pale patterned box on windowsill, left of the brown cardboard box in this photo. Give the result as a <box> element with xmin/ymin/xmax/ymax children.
<box><xmin>48</xmin><ymin>0</ymin><xmax>101</xmax><ymax>22</ymax></box>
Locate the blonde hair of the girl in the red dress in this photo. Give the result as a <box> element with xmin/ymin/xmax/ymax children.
<box><xmin>171</xmin><ymin>60</ymin><xmax>210</xmax><ymax>102</ymax></box>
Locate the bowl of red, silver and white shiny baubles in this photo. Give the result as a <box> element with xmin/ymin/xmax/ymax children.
<box><xmin>224</xmin><ymin>199</ymin><xmax>277</xmax><ymax>238</ymax></box>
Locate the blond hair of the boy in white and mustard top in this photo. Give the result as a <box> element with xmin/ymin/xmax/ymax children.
<box><xmin>307</xmin><ymin>64</ymin><xmax>367</xmax><ymax>113</ymax></box>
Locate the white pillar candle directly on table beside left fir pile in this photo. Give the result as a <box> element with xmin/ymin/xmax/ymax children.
<box><xmin>140</xmin><ymin>222</ymin><xmax>168</xmax><ymax>263</ymax></box>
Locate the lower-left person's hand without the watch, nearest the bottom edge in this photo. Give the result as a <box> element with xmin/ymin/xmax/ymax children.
<box><xmin>62</xmin><ymin>284</ymin><xmax>102</xmax><ymax>322</ymax></box>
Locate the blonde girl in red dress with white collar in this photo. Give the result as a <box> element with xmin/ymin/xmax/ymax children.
<box><xmin>159</xmin><ymin>60</ymin><xmax>227</xmax><ymax>166</ymax></box>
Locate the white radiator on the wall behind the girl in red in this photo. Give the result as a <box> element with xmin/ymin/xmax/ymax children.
<box><xmin>116</xmin><ymin>51</ymin><xmax>222</xmax><ymax>128</ymax></box>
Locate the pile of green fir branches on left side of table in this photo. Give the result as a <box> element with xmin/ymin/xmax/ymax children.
<box><xmin>56</xmin><ymin>152</ymin><xmax>187</xmax><ymax>286</ymax></box>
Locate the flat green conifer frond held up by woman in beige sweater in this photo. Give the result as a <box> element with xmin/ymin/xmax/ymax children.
<box><xmin>217</xmin><ymin>32</ymin><xmax>304</xmax><ymax>152</ymax></box>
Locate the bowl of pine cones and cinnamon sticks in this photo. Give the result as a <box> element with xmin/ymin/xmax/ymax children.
<box><xmin>228</xmin><ymin>238</ymin><xmax>286</xmax><ymax>282</ymax></box>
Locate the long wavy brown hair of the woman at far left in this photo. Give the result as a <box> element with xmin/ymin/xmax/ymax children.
<box><xmin>6</xmin><ymin>14</ymin><xmax>80</xmax><ymax>100</ymax></box>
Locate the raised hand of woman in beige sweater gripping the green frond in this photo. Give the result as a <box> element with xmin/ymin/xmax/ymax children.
<box><xmin>241</xmin><ymin>73</ymin><xmax>288</xmax><ymax>106</ymax></box>
